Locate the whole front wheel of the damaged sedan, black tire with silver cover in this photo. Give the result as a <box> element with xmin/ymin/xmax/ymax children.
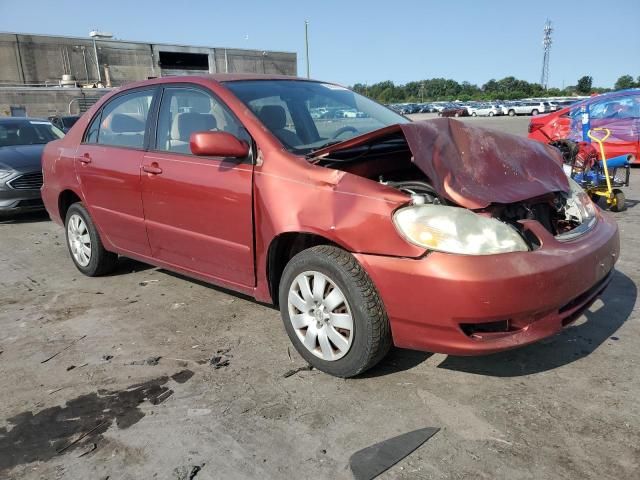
<box><xmin>279</xmin><ymin>245</ymin><xmax>391</xmax><ymax>378</ymax></box>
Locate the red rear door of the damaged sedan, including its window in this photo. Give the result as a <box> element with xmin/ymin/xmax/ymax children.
<box><xmin>75</xmin><ymin>88</ymin><xmax>155</xmax><ymax>256</ymax></box>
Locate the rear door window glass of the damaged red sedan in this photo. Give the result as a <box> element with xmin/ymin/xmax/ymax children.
<box><xmin>95</xmin><ymin>90</ymin><xmax>153</xmax><ymax>148</ymax></box>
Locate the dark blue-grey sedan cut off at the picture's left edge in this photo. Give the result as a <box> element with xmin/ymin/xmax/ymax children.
<box><xmin>0</xmin><ymin>117</ymin><xmax>64</xmax><ymax>216</ymax></box>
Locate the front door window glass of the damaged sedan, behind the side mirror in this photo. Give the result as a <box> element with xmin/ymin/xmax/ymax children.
<box><xmin>156</xmin><ymin>87</ymin><xmax>251</xmax><ymax>154</ymax></box>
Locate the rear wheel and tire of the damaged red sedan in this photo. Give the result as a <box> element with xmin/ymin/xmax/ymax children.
<box><xmin>64</xmin><ymin>203</ymin><xmax>118</xmax><ymax>277</ymax></box>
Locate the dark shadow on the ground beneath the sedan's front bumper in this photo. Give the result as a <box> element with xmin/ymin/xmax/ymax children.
<box><xmin>438</xmin><ymin>271</ymin><xmax>638</xmax><ymax>377</ymax></box>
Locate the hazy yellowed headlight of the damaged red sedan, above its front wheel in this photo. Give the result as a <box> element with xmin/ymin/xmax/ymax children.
<box><xmin>393</xmin><ymin>205</ymin><xmax>529</xmax><ymax>255</ymax></box>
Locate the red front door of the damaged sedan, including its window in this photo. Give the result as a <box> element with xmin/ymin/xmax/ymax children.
<box><xmin>142</xmin><ymin>84</ymin><xmax>255</xmax><ymax>287</ymax></box>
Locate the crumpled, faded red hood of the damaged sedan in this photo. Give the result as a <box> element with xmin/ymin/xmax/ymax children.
<box><xmin>400</xmin><ymin>118</ymin><xmax>569</xmax><ymax>209</ymax></box>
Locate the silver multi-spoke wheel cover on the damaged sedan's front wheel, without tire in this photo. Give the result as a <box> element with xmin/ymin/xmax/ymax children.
<box><xmin>288</xmin><ymin>271</ymin><xmax>354</xmax><ymax>361</ymax></box>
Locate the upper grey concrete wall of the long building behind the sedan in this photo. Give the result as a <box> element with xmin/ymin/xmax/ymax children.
<box><xmin>0</xmin><ymin>33</ymin><xmax>297</xmax><ymax>86</ymax></box>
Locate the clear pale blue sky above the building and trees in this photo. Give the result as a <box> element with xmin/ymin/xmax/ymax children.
<box><xmin>0</xmin><ymin>0</ymin><xmax>640</xmax><ymax>87</ymax></box>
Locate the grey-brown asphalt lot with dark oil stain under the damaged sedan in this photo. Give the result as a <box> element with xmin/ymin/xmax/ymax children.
<box><xmin>0</xmin><ymin>117</ymin><xmax>640</xmax><ymax>480</ymax></box>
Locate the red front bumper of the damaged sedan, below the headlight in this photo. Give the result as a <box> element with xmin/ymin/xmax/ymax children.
<box><xmin>355</xmin><ymin>212</ymin><xmax>620</xmax><ymax>355</ymax></box>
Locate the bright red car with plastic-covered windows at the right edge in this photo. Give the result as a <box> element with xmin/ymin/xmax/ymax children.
<box><xmin>529</xmin><ymin>88</ymin><xmax>640</xmax><ymax>162</ymax></box>
